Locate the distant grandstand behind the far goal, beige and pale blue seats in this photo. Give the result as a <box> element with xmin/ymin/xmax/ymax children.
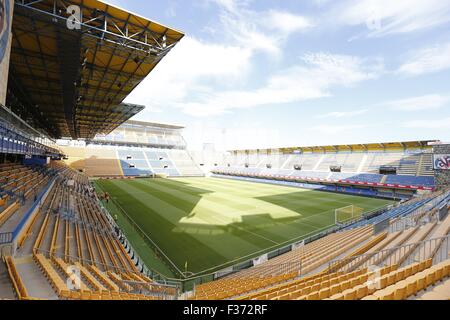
<box><xmin>59</xmin><ymin>120</ymin><xmax>203</xmax><ymax>178</ymax></box>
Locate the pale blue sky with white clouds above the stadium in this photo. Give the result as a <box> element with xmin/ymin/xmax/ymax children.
<box><xmin>104</xmin><ymin>0</ymin><xmax>450</xmax><ymax>149</ymax></box>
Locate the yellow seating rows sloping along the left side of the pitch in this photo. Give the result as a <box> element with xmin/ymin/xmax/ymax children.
<box><xmin>11</xmin><ymin>166</ymin><xmax>176</xmax><ymax>300</ymax></box>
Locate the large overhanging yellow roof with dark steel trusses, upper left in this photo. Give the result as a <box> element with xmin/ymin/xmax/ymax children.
<box><xmin>9</xmin><ymin>0</ymin><xmax>184</xmax><ymax>139</ymax></box>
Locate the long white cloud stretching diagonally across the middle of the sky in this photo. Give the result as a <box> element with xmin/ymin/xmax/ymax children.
<box><xmin>174</xmin><ymin>53</ymin><xmax>381</xmax><ymax>116</ymax></box>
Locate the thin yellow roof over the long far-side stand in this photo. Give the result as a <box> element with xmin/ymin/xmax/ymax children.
<box><xmin>230</xmin><ymin>140</ymin><xmax>439</xmax><ymax>153</ymax></box>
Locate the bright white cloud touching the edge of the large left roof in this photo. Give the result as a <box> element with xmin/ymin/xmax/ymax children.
<box><xmin>126</xmin><ymin>36</ymin><xmax>251</xmax><ymax>114</ymax></box>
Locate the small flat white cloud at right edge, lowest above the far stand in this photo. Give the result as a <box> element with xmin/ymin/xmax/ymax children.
<box><xmin>384</xmin><ymin>94</ymin><xmax>450</xmax><ymax>111</ymax></box>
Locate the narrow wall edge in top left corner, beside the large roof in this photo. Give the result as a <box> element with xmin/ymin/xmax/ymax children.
<box><xmin>0</xmin><ymin>0</ymin><xmax>14</xmax><ymax>105</ymax></box>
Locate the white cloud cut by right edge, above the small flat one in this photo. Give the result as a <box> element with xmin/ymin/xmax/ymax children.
<box><xmin>398</xmin><ymin>43</ymin><xmax>450</xmax><ymax>75</ymax></box>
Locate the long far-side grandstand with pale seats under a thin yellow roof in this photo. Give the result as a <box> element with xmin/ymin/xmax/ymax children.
<box><xmin>212</xmin><ymin>141</ymin><xmax>435</xmax><ymax>198</ymax></box>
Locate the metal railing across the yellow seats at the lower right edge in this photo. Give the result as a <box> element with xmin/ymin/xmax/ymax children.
<box><xmin>328</xmin><ymin>235</ymin><xmax>450</xmax><ymax>273</ymax></box>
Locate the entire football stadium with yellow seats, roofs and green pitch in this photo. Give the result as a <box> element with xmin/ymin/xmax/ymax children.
<box><xmin>0</xmin><ymin>0</ymin><xmax>450</xmax><ymax>303</ymax></box>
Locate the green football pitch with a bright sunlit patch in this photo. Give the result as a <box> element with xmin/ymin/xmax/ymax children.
<box><xmin>96</xmin><ymin>178</ymin><xmax>390</xmax><ymax>277</ymax></box>
